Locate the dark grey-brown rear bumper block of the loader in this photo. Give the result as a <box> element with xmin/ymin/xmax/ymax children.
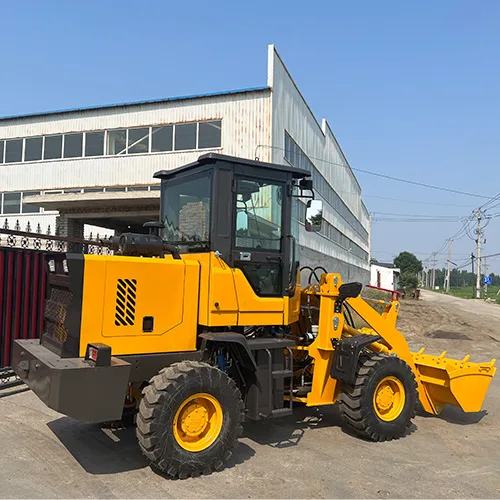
<box><xmin>12</xmin><ymin>340</ymin><xmax>130</xmax><ymax>423</ymax></box>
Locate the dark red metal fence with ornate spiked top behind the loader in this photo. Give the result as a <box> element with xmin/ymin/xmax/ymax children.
<box><xmin>0</xmin><ymin>221</ymin><xmax>112</xmax><ymax>388</ymax></box>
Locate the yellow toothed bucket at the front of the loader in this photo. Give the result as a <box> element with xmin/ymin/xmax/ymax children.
<box><xmin>412</xmin><ymin>349</ymin><xmax>496</xmax><ymax>413</ymax></box>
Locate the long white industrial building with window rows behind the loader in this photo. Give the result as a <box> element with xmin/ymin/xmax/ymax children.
<box><xmin>0</xmin><ymin>45</ymin><xmax>370</xmax><ymax>283</ymax></box>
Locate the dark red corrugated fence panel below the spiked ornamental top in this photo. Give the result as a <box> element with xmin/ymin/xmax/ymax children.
<box><xmin>0</xmin><ymin>248</ymin><xmax>49</xmax><ymax>368</ymax></box>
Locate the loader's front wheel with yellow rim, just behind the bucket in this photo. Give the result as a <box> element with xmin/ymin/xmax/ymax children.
<box><xmin>338</xmin><ymin>354</ymin><xmax>418</xmax><ymax>441</ymax></box>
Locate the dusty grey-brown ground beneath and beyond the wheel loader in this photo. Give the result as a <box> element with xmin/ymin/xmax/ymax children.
<box><xmin>0</xmin><ymin>292</ymin><xmax>500</xmax><ymax>498</ymax></box>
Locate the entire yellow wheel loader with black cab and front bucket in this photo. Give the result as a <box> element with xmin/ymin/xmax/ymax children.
<box><xmin>13</xmin><ymin>153</ymin><xmax>496</xmax><ymax>478</ymax></box>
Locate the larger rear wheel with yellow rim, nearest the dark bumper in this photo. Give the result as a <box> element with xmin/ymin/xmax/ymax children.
<box><xmin>137</xmin><ymin>361</ymin><xmax>245</xmax><ymax>479</ymax></box>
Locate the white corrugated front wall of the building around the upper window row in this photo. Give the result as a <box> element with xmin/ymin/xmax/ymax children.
<box><xmin>0</xmin><ymin>90</ymin><xmax>271</xmax><ymax>191</ymax></box>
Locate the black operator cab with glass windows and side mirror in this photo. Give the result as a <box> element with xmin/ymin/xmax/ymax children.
<box><xmin>154</xmin><ymin>153</ymin><xmax>321</xmax><ymax>297</ymax></box>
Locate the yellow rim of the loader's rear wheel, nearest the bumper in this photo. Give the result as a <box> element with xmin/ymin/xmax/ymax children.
<box><xmin>174</xmin><ymin>393</ymin><xmax>223</xmax><ymax>452</ymax></box>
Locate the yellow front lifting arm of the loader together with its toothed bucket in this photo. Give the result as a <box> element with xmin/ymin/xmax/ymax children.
<box><xmin>297</xmin><ymin>274</ymin><xmax>496</xmax><ymax>415</ymax></box>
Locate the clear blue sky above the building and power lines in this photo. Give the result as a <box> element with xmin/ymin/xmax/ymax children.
<box><xmin>0</xmin><ymin>0</ymin><xmax>500</xmax><ymax>272</ymax></box>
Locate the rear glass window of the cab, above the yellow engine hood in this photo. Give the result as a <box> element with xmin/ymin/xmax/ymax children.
<box><xmin>162</xmin><ymin>173</ymin><xmax>212</xmax><ymax>252</ymax></box>
